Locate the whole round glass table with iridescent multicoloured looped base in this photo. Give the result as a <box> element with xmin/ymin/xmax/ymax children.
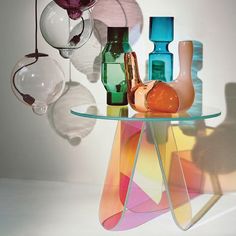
<box><xmin>71</xmin><ymin>104</ymin><xmax>222</xmax><ymax>230</ymax></box>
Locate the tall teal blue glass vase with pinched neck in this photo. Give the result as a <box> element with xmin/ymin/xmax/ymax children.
<box><xmin>148</xmin><ymin>17</ymin><xmax>174</xmax><ymax>82</ymax></box>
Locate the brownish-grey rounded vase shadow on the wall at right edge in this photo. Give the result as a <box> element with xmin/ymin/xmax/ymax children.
<box><xmin>192</xmin><ymin>83</ymin><xmax>236</xmax><ymax>192</ymax></box>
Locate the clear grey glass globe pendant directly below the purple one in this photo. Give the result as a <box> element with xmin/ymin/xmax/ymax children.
<box><xmin>40</xmin><ymin>1</ymin><xmax>93</xmax><ymax>58</ymax></box>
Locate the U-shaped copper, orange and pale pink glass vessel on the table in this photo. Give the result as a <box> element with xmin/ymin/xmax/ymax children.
<box><xmin>125</xmin><ymin>41</ymin><xmax>194</xmax><ymax>113</ymax></box>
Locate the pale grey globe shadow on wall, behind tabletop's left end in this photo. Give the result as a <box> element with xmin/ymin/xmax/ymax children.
<box><xmin>48</xmin><ymin>82</ymin><xmax>97</xmax><ymax>146</ymax></box>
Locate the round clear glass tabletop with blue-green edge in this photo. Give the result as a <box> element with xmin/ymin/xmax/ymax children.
<box><xmin>71</xmin><ymin>104</ymin><xmax>221</xmax><ymax>122</ymax></box>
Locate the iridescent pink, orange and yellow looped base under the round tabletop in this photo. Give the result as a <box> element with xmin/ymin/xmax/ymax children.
<box><xmin>99</xmin><ymin>121</ymin><xmax>222</xmax><ymax>231</ymax></box>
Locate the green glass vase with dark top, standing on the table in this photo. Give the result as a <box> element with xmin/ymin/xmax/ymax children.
<box><xmin>102</xmin><ymin>27</ymin><xmax>132</xmax><ymax>106</ymax></box>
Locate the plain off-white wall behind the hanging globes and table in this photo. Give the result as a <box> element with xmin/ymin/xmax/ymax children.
<box><xmin>0</xmin><ymin>0</ymin><xmax>236</xmax><ymax>183</ymax></box>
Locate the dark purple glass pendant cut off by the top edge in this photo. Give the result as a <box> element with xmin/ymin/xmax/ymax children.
<box><xmin>54</xmin><ymin>0</ymin><xmax>97</xmax><ymax>20</ymax></box>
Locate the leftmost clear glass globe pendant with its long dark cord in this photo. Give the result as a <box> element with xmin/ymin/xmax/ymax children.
<box><xmin>11</xmin><ymin>0</ymin><xmax>65</xmax><ymax>115</ymax></box>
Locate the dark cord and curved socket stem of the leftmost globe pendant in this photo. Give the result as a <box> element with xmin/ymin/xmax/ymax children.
<box><xmin>12</xmin><ymin>0</ymin><xmax>39</xmax><ymax>106</ymax></box>
